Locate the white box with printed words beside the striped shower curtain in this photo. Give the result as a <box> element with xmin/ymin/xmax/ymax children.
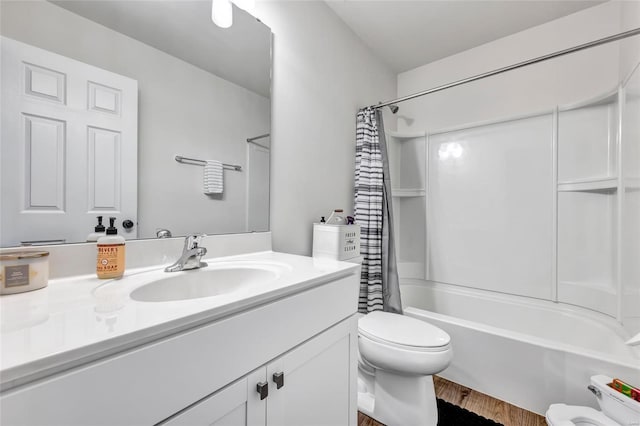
<box><xmin>313</xmin><ymin>223</ymin><xmax>360</xmax><ymax>260</ymax></box>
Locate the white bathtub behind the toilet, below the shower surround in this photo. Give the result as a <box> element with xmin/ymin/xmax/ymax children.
<box><xmin>401</xmin><ymin>281</ymin><xmax>640</xmax><ymax>414</ymax></box>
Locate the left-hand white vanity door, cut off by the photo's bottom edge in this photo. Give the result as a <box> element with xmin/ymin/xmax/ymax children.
<box><xmin>161</xmin><ymin>367</ymin><xmax>267</xmax><ymax>426</ymax></box>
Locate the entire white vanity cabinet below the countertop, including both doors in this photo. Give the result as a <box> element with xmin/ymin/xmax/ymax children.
<box><xmin>0</xmin><ymin>269</ymin><xmax>359</xmax><ymax>426</ymax></box>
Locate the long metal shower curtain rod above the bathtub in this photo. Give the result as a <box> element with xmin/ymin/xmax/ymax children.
<box><xmin>368</xmin><ymin>28</ymin><xmax>640</xmax><ymax>108</ymax></box>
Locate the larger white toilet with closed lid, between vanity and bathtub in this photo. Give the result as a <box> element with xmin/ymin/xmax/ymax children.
<box><xmin>358</xmin><ymin>311</ymin><xmax>453</xmax><ymax>426</ymax></box>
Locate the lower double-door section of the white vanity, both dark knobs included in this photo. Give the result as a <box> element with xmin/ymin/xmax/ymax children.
<box><xmin>161</xmin><ymin>319</ymin><xmax>355</xmax><ymax>426</ymax></box>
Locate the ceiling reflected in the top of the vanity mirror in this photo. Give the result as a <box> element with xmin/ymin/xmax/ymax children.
<box><xmin>50</xmin><ymin>0</ymin><xmax>271</xmax><ymax>97</ymax></box>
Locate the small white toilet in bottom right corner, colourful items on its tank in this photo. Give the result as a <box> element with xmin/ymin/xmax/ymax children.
<box><xmin>546</xmin><ymin>375</ymin><xmax>640</xmax><ymax>426</ymax></box>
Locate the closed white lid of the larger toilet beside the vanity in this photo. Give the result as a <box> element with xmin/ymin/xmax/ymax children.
<box><xmin>358</xmin><ymin>311</ymin><xmax>451</xmax><ymax>348</ymax></box>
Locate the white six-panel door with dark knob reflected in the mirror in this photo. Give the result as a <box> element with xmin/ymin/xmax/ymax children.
<box><xmin>0</xmin><ymin>37</ymin><xmax>138</xmax><ymax>247</ymax></box>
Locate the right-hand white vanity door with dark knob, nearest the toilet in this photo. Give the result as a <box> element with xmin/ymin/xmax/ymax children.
<box><xmin>267</xmin><ymin>318</ymin><xmax>357</xmax><ymax>426</ymax></box>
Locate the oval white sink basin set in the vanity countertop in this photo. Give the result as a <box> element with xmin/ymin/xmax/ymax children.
<box><xmin>130</xmin><ymin>264</ymin><xmax>280</xmax><ymax>302</ymax></box>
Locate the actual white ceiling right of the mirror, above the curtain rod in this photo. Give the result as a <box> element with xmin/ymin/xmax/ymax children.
<box><xmin>326</xmin><ymin>0</ymin><xmax>604</xmax><ymax>73</ymax></box>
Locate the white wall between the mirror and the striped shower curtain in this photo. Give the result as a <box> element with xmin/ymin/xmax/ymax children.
<box><xmin>256</xmin><ymin>1</ymin><xmax>396</xmax><ymax>255</ymax></box>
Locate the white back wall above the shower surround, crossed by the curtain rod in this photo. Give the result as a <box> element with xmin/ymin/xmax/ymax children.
<box><xmin>398</xmin><ymin>1</ymin><xmax>639</xmax><ymax>131</ymax></box>
